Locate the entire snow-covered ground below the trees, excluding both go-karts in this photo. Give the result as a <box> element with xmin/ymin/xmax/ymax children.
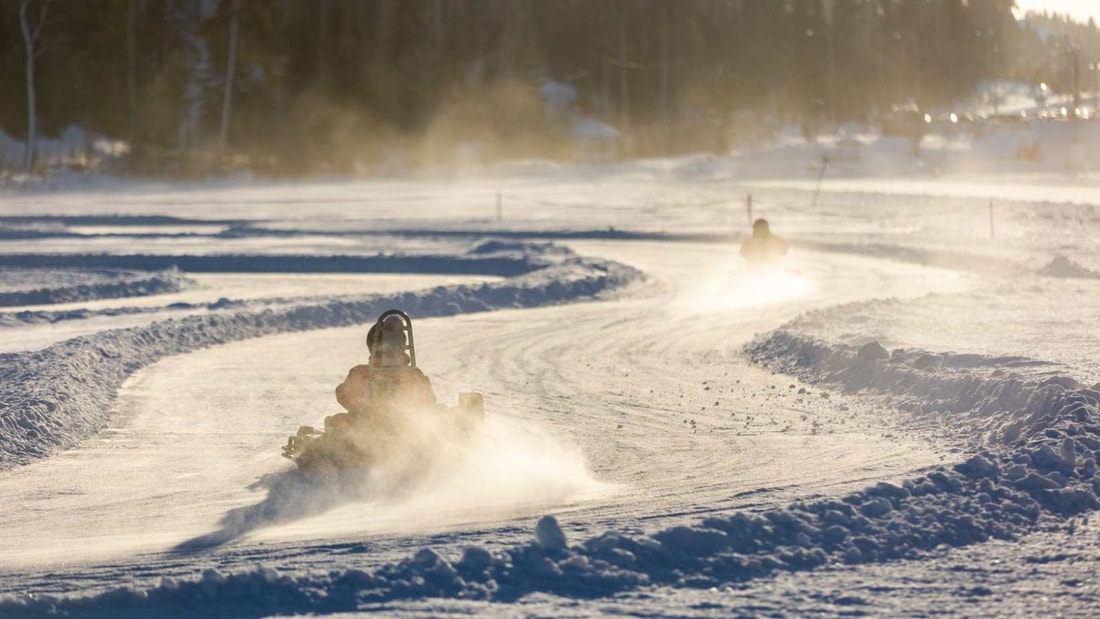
<box><xmin>0</xmin><ymin>152</ymin><xmax>1100</xmax><ymax>617</ymax></box>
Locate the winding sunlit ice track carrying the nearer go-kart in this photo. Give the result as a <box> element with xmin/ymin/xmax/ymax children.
<box><xmin>0</xmin><ymin>242</ymin><xmax>966</xmax><ymax>593</ymax></box>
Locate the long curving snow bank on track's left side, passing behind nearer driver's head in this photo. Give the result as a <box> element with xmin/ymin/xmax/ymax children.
<box><xmin>0</xmin><ymin>248</ymin><xmax>640</xmax><ymax>468</ymax></box>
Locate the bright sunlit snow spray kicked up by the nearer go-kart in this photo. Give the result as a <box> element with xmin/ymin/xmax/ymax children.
<box><xmin>250</xmin><ymin>411</ymin><xmax>608</xmax><ymax>545</ymax></box>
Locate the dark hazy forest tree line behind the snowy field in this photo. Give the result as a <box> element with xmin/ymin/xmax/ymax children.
<box><xmin>0</xmin><ymin>0</ymin><xmax>1100</xmax><ymax>174</ymax></box>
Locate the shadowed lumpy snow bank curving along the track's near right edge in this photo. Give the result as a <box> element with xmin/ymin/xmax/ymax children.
<box><xmin>0</xmin><ymin>331</ymin><xmax>1100</xmax><ymax>617</ymax></box>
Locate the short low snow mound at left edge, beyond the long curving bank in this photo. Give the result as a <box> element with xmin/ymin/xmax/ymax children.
<box><xmin>0</xmin><ymin>268</ymin><xmax>195</xmax><ymax>307</ymax></box>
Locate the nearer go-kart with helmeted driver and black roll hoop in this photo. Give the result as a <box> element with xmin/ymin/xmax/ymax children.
<box><xmin>283</xmin><ymin>310</ymin><xmax>485</xmax><ymax>477</ymax></box>
